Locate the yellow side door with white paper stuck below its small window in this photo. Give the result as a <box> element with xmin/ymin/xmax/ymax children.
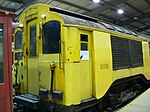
<box><xmin>79</xmin><ymin>30</ymin><xmax>92</xmax><ymax>100</ymax></box>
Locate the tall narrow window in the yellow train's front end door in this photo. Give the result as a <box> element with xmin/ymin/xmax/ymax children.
<box><xmin>30</xmin><ymin>26</ymin><xmax>36</xmax><ymax>56</ymax></box>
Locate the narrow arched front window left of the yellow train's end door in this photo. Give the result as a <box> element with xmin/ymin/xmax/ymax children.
<box><xmin>15</xmin><ymin>30</ymin><xmax>22</xmax><ymax>49</ymax></box>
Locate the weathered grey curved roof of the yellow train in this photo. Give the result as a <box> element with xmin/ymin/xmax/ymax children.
<box><xmin>60</xmin><ymin>14</ymin><xmax>150</xmax><ymax>41</ymax></box>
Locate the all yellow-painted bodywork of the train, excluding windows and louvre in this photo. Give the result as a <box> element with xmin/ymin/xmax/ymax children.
<box><xmin>14</xmin><ymin>4</ymin><xmax>150</xmax><ymax>106</ymax></box>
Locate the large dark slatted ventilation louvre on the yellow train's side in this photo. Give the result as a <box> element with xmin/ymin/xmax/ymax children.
<box><xmin>111</xmin><ymin>36</ymin><xmax>143</xmax><ymax>70</ymax></box>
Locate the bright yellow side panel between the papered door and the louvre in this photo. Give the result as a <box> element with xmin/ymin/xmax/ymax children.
<box><xmin>93</xmin><ymin>31</ymin><xmax>113</xmax><ymax>99</ymax></box>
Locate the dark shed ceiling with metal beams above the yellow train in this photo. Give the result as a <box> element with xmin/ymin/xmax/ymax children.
<box><xmin>0</xmin><ymin>0</ymin><xmax>150</xmax><ymax>35</ymax></box>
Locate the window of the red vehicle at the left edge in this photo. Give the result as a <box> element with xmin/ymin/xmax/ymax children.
<box><xmin>0</xmin><ymin>24</ymin><xmax>4</xmax><ymax>83</ymax></box>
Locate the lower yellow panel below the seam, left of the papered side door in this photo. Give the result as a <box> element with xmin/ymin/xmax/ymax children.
<box><xmin>65</xmin><ymin>63</ymin><xmax>81</xmax><ymax>106</ymax></box>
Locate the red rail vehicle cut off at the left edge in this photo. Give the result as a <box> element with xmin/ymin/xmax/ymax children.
<box><xmin>0</xmin><ymin>11</ymin><xmax>14</xmax><ymax>112</ymax></box>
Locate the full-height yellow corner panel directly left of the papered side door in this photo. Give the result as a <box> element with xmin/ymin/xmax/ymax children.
<box><xmin>64</xmin><ymin>27</ymin><xmax>81</xmax><ymax>106</ymax></box>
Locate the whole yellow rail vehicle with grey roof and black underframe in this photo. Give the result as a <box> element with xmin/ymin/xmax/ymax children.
<box><xmin>14</xmin><ymin>4</ymin><xmax>150</xmax><ymax>112</ymax></box>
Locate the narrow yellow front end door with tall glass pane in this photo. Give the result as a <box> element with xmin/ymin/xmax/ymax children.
<box><xmin>26</xmin><ymin>19</ymin><xmax>39</xmax><ymax>95</ymax></box>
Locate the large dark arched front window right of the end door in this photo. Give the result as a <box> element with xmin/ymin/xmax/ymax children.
<box><xmin>42</xmin><ymin>20</ymin><xmax>61</xmax><ymax>54</ymax></box>
